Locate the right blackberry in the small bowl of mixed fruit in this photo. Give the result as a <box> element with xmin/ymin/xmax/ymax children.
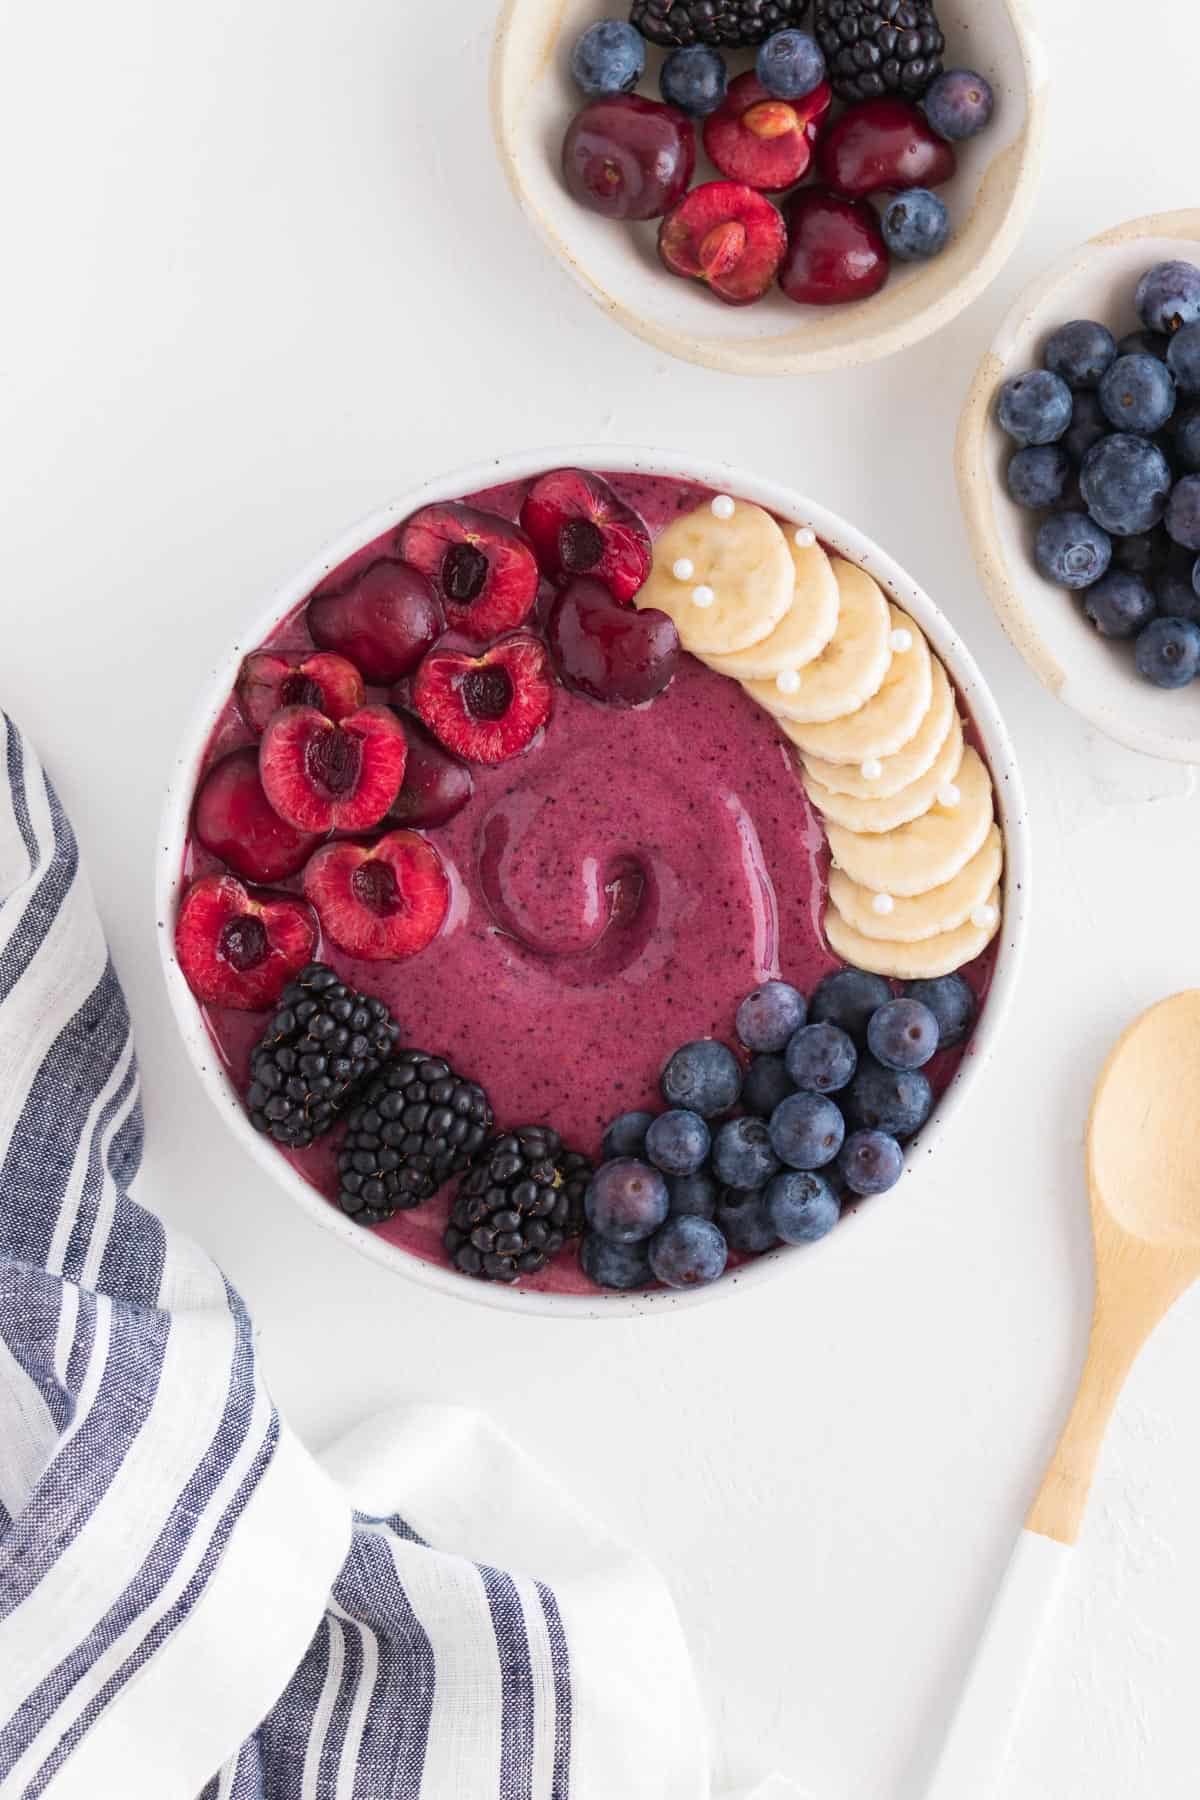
<box><xmin>815</xmin><ymin>0</ymin><xmax>946</xmax><ymax>101</ymax></box>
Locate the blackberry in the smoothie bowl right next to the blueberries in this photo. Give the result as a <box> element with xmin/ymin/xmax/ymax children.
<box><xmin>444</xmin><ymin>1125</ymin><xmax>592</xmax><ymax>1282</ymax></box>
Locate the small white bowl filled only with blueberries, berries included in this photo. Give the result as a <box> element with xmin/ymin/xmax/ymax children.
<box><xmin>957</xmin><ymin>211</ymin><xmax>1200</xmax><ymax>763</ymax></box>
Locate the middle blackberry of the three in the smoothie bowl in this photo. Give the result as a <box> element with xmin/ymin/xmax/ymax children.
<box><xmin>338</xmin><ymin>1049</ymin><xmax>493</xmax><ymax>1226</ymax></box>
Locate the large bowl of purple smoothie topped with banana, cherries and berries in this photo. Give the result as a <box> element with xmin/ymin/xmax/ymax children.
<box><xmin>158</xmin><ymin>448</ymin><xmax>1027</xmax><ymax>1316</ymax></box>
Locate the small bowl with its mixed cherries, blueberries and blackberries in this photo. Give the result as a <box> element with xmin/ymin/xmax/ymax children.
<box><xmin>495</xmin><ymin>0</ymin><xmax>1040</xmax><ymax>373</ymax></box>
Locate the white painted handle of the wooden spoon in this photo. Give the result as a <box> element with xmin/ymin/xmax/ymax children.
<box><xmin>927</xmin><ymin>1532</ymin><xmax>1070</xmax><ymax>1800</ymax></box>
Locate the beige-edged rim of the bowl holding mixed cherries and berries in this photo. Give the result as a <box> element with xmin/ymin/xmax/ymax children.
<box><xmin>489</xmin><ymin>0</ymin><xmax>1049</xmax><ymax>374</ymax></box>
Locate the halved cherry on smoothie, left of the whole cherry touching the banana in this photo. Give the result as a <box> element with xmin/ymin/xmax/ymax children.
<box><xmin>412</xmin><ymin>632</ymin><xmax>554</xmax><ymax>763</ymax></box>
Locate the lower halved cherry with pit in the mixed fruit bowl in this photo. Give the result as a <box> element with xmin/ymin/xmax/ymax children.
<box><xmin>658</xmin><ymin>182</ymin><xmax>788</xmax><ymax>306</ymax></box>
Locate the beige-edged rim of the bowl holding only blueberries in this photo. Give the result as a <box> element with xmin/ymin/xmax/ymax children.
<box><xmin>955</xmin><ymin>207</ymin><xmax>1200</xmax><ymax>765</ymax></box>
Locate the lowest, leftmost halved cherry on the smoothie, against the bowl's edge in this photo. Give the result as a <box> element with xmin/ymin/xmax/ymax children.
<box><xmin>175</xmin><ymin>875</ymin><xmax>318</xmax><ymax>1012</ymax></box>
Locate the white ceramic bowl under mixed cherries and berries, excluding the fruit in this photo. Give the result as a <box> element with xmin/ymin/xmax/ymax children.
<box><xmin>491</xmin><ymin>0</ymin><xmax>1045</xmax><ymax>374</ymax></box>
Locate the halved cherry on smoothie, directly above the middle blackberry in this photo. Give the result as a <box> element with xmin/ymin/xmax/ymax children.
<box><xmin>304</xmin><ymin>832</ymin><xmax>450</xmax><ymax>963</ymax></box>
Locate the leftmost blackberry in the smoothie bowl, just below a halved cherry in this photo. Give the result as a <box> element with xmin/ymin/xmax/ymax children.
<box><xmin>246</xmin><ymin>963</ymin><xmax>399</xmax><ymax>1150</ymax></box>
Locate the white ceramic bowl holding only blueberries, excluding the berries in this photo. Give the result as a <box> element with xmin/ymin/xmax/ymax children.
<box><xmin>957</xmin><ymin>209</ymin><xmax>1200</xmax><ymax>763</ymax></box>
